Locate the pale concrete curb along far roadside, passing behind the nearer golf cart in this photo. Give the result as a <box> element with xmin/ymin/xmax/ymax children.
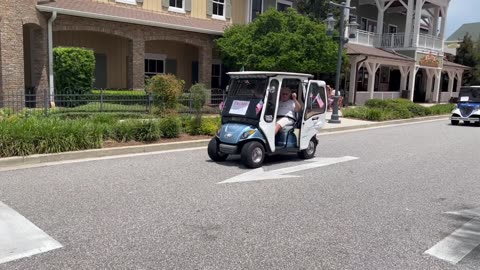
<box><xmin>0</xmin><ymin>115</ymin><xmax>448</xmax><ymax>168</ymax></box>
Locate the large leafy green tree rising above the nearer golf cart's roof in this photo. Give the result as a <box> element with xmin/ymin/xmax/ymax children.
<box><xmin>216</xmin><ymin>8</ymin><xmax>346</xmax><ymax>73</ymax></box>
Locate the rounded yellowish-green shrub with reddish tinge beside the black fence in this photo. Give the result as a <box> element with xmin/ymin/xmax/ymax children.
<box><xmin>145</xmin><ymin>74</ymin><xmax>185</xmax><ymax>111</ymax></box>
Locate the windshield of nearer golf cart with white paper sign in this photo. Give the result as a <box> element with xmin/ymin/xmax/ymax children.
<box><xmin>222</xmin><ymin>77</ymin><xmax>268</xmax><ymax>124</ymax></box>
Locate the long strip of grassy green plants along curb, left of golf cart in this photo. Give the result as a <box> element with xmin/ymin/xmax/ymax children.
<box><xmin>0</xmin><ymin>115</ymin><xmax>220</xmax><ymax>157</ymax></box>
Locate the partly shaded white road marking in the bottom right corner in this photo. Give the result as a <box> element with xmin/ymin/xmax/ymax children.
<box><xmin>425</xmin><ymin>208</ymin><xmax>480</xmax><ymax>264</ymax></box>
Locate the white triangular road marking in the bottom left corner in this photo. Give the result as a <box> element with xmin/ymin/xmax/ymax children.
<box><xmin>0</xmin><ymin>202</ymin><xmax>62</xmax><ymax>264</ymax></box>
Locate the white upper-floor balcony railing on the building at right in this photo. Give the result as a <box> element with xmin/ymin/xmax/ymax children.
<box><xmin>349</xmin><ymin>30</ymin><xmax>443</xmax><ymax>51</ymax></box>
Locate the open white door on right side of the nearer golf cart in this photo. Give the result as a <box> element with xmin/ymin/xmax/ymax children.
<box><xmin>300</xmin><ymin>80</ymin><xmax>327</xmax><ymax>150</ymax></box>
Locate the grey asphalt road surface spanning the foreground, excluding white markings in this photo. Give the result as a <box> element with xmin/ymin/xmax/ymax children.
<box><xmin>0</xmin><ymin>120</ymin><xmax>480</xmax><ymax>270</ymax></box>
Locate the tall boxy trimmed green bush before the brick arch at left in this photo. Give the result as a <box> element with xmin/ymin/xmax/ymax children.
<box><xmin>53</xmin><ymin>47</ymin><xmax>95</xmax><ymax>107</ymax></box>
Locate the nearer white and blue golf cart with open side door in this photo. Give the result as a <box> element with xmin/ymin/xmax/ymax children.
<box><xmin>208</xmin><ymin>71</ymin><xmax>327</xmax><ymax>168</ymax></box>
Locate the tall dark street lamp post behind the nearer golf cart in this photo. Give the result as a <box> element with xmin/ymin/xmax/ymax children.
<box><xmin>324</xmin><ymin>1</ymin><xmax>358</xmax><ymax>124</ymax></box>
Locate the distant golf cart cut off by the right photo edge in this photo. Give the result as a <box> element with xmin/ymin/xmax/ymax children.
<box><xmin>450</xmin><ymin>86</ymin><xmax>480</xmax><ymax>126</ymax></box>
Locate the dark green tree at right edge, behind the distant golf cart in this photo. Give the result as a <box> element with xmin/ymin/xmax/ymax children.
<box><xmin>455</xmin><ymin>33</ymin><xmax>480</xmax><ymax>85</ymax></box>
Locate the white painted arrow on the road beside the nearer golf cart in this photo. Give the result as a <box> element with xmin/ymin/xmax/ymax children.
<box><xmin>217</xmin><ymin>156</ymin><xmax>358</xmax><ymax>184</ymax></box>
